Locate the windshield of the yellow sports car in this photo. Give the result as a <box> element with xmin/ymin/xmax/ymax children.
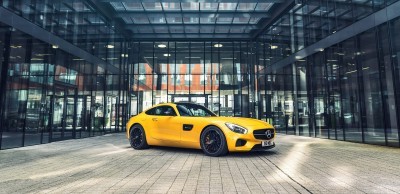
<box><xmin>176</xmin><ymin>103</ymin><xmax>216</xmax><ymax>117</ymax></box>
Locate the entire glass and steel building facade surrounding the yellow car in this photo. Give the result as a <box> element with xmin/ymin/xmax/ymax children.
<box><xmin>0</xmin><ymin>0</ymin><xmax>400</xmax><ymax>149</ymax></box>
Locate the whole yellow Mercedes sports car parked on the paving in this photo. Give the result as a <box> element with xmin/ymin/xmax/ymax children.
<box><xmin>126</xmin><ymin>102</ymin><xmax>275</xmax><ymax>156</ymax></box>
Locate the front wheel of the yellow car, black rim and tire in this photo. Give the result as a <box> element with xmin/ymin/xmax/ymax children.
<box><xmin>200</xmin><ymin>126</ymin><xmax>228</xmax><ymax>157</ymax></box>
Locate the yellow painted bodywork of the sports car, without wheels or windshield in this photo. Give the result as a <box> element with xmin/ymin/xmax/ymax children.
<box><xmin>126</xmin><ymin>103</ymin><xmax>276</xmax><ymax>152</ymax></box>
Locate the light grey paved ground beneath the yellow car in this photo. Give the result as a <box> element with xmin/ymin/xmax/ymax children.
<box><xmin>0</xmin><ymin>134</ymin><xmax>400</xmax><ymax>194</ymax></box>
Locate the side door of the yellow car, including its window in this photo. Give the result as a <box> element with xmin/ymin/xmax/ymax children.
<box><xmin>152</xmin><ymin>105</ymin><xmax>181</xmax><ymax>146</ymax></box>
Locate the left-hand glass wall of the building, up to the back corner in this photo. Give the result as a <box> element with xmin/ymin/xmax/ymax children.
<box><xmin>0</xmin><ymin>0</ymin><xmax>128</xmax><ymax>149</ymax></box>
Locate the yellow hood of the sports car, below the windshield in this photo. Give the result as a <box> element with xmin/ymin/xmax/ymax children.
<box><xmin>208</xmin><ymin>117</ymin><xmax>273</xmax><ymax>129</ymax></box>
